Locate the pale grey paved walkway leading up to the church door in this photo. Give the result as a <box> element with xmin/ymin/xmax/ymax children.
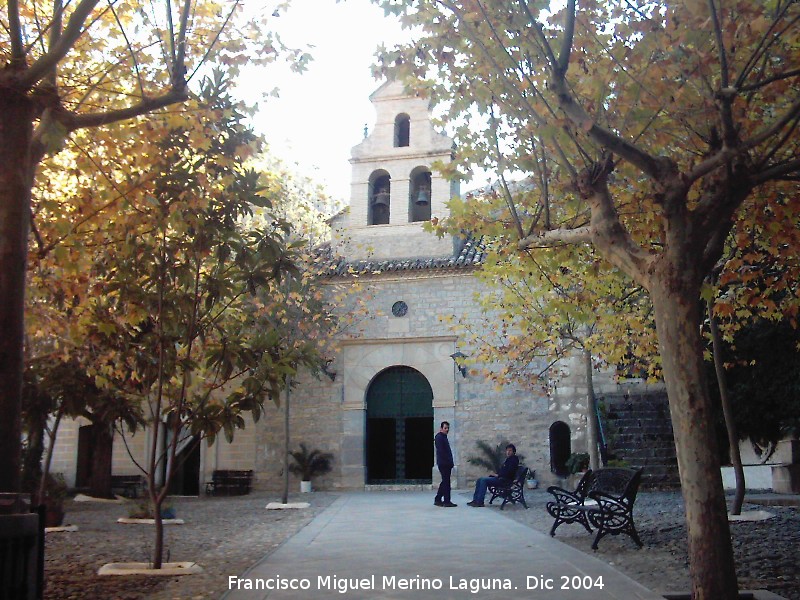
<box><xmin>224</xmin><ymin>492</ymin><xmax>663</xmax><ymax>600</ymax></box>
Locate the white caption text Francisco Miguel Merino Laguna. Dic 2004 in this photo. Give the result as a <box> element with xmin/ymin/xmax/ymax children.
<box><xmin>228</xmin><ymin>575</ymin><xmax>603</xmax><ymax>594</ymax></box>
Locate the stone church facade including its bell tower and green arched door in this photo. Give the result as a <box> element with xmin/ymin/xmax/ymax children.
<box><xmin>51</xmin><ymin>82</ymin><xmax>660</xmax><ymax>494</ymax></box>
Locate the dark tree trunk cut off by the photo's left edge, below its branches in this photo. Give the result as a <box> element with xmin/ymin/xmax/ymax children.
<box><xmin>0</xmin><ymin>94</ymin><xmax>33</xmax><ymax>492</ymax></box>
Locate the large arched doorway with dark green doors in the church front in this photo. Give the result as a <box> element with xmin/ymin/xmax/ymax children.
<box><xmin>367</xmin><ymin>367</ymin><xmax>433</xmax><ymax>484</ymax></box>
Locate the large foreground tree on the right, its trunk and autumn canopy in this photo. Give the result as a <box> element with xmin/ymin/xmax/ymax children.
<box><xmin>377</xmin><ymin>0</ymin><xmax>800</xmax><ymax>599</ymax></box>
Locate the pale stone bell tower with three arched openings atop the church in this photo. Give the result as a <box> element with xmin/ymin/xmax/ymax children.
<box><xmin>337</xmin><ymin>81</ymin><xmax>458</xmax><ymax>260</ymax></box>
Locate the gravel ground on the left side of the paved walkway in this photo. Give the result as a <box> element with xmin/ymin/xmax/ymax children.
<box><xmin>45</xmin><ymin>492</ymin><xmax>336</xmax><ymax>600</ymax></box>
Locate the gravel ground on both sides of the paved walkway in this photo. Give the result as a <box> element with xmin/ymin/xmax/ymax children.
<box><xmin>45</xmin><ymin>490</ymin><xmax>800</xmax><ymax>600</ymax></box>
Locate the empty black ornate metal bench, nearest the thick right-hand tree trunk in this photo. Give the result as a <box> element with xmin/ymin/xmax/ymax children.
<box><xmin>547</xmin><ymin>468</ymin><xmax>643</xmax><ymax>550</ymax></box>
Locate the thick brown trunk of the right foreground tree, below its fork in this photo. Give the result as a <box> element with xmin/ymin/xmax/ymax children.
<box><xmin>650</xmin><ymin>282</ymin><xmax>738</xmax><ymax>600</ymax></box>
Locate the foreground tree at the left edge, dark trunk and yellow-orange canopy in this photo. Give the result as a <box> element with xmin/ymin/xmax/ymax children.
<box><xmin>0</xmin><ymin>0</ymin><xmax>308</xmax><ymax>491</ymax></box>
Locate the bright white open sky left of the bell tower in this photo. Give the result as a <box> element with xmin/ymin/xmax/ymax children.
<box><xmin>240</xmin><ymin>0</ymin><xmax>410</xmax><ymax>203</ymax></box>
